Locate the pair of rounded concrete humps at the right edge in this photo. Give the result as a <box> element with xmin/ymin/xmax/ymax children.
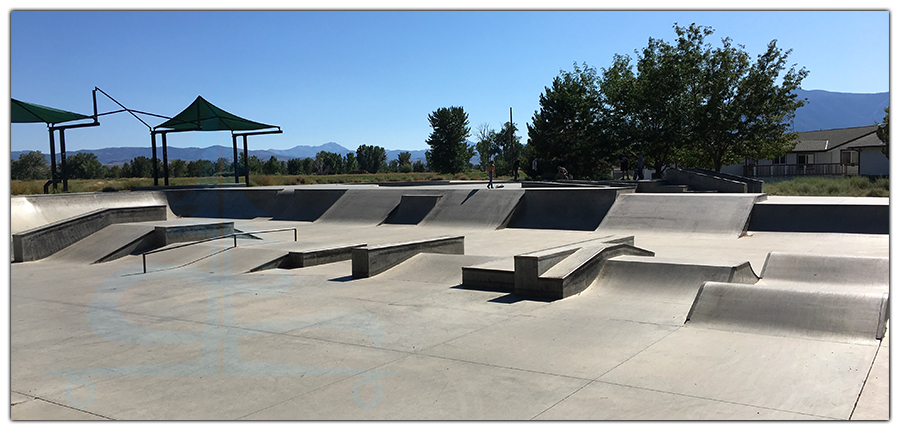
<box><xmin>688</xmin><ymin>253</ymin><xmax>890</xmax><ymax>341</ymax></box>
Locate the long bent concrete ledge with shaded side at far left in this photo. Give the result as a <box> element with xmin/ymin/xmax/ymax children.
<box><xmin>12</xmin><ymin>205</ymin><xmax>166</xmax><ymax>261</ymax></box>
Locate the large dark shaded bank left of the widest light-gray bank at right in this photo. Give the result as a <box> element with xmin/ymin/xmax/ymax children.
<box><xmin>506</xmin><ymin>188</ymin><xmax>621</xmax><ymax>231</ymax></box>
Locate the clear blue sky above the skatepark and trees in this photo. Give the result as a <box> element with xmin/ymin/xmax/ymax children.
<box><xmin>9</xmin><ymin>8</ymin><xmax>889</xmax><ymax>152</ymax></box>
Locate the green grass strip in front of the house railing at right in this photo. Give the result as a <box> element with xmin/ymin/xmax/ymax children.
<box><xmin>763</xmin><ymin>176</ymin><xmax>890</xmax><ymax>197</ymax></box>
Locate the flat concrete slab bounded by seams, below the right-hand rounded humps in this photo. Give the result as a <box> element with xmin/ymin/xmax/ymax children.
<box><xmin>598</xmin><ymin>327</ymin><xmax>877</xmax><ymax>420</ymax></box>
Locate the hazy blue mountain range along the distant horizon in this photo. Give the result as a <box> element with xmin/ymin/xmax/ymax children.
<box><xmin>10</xmin><ymin>89</ymin><xmax>890</xmax><ymax>165</ymax></box>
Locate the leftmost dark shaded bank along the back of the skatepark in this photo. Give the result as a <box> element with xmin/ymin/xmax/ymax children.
<box><xmin>165</xmin><ymin>188</ymin><xmax>282</xmax><ymax>219</ymax></box>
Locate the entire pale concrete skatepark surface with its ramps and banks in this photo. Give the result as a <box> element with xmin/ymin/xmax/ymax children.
<box><xmin>10</xmin><ymin>182</ymin><xmax>890</xmax><ymax>421</ymax></box>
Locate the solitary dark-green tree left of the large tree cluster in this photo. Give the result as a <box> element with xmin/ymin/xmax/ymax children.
<box><xmin>425</xmin><ymin>107</ymin><xmax>475</xmax><ymax>174</ymax></box>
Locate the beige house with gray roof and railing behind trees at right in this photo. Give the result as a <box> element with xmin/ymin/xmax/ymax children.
<box><xmin>725</xmin><ymin>125</ymin><xmax>889</xmax><ymax>178</ymax></box>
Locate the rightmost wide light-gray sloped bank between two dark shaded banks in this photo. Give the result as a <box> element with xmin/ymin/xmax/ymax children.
<box><xmin>597</xmin><ymin>193</ymin><xmax>765</xmax><ymax>237</ymax></box>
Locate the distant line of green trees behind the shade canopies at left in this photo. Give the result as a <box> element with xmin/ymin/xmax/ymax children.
<box><xmin>10</xmin><ymin>144</ymin><xmax>427</xmax><ymax>180</ymax></box>
